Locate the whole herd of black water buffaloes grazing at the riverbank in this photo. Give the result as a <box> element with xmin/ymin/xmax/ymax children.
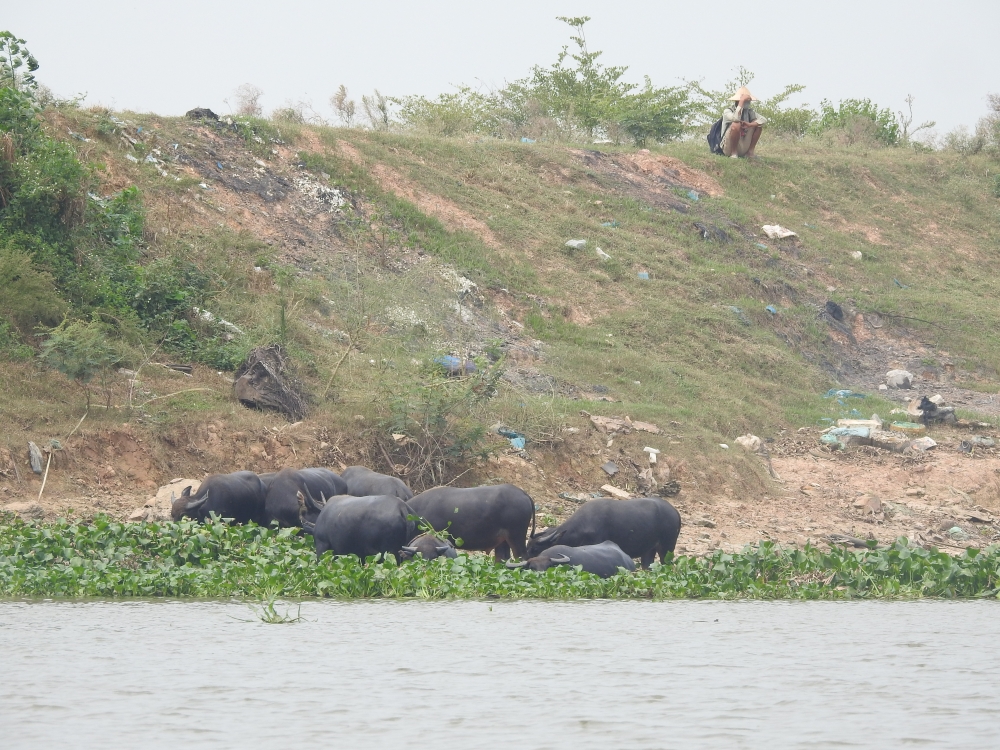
<box><xmin>171</xmin><ymin>466</ymin><xmax>681</xmax><ymax>578</ymax></box>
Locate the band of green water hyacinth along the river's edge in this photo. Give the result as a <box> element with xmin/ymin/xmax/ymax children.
<box><xmin>0</xmin><ymin>516</ymin><xmax>1000</xmax><ymax>599</ymax></box>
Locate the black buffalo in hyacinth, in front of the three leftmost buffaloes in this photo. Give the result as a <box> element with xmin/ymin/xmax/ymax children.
<box><xmin>301</xmin><ymin>495</ymin><xmax>416</xmax><ymax>562</ymax></box>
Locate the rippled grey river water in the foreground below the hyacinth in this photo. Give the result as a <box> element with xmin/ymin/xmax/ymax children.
<box><xmin>0</xmin><ymin>602</ymin><xmax>1000</xmax><ymax>750</ymax></box>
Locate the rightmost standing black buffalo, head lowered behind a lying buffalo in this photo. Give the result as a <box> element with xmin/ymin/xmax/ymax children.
<box><xmin>528</xmin><ymin>497</ymin><xmax>681</xmax><ymax>568</ymax></box>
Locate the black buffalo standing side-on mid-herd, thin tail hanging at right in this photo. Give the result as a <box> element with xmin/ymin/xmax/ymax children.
<box><xmin>408</xmin><ymin>484</ymin><xmax>535</xmax><ymax>560</ymax></box>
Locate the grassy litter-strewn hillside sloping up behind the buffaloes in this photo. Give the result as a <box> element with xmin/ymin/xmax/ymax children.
<box><xmin>0</xmin><ymin>101</ymin><xmax>1000</xmax><ymax>512</ymax></box>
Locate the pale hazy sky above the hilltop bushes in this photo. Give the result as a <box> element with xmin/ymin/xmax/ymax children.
<box><xmin>7</xmin><ymin>0</ymin><xmax>1000</xmax><ymax>133</ymax></box>
